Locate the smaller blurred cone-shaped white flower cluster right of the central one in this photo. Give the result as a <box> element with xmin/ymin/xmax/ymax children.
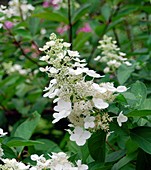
<box><xmin>95</xmin><ymin>35</ymin><xmax>132</xmax><ymax>73</ymax></box>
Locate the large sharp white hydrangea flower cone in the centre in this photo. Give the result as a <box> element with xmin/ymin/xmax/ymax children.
<box><xmin>40</xmin><ymin>33</ymin><xmax>127</xmax><ymax>146</ymax></box>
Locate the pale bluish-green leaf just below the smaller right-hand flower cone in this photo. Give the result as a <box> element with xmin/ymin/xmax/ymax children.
<box><xmin>117</xmin><ymin>64</ymin><xmax>134</xmax><ymax>84</ymax></box>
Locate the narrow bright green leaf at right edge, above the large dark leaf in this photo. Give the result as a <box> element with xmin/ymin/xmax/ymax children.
<box><xmin>126</xmin><ymin>110</ymin><xmax>151</xmax><ymax>117</ymax></box>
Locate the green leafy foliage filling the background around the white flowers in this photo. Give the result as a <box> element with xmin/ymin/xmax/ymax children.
<box><xmin>0</xmin><ymin>0</ymin><xmax>151</xmax><ymax>170</ymax></box>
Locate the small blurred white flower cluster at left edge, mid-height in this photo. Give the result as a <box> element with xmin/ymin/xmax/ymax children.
<box><xmin>2</xmin><ymin>62</ymin><xmax>31</xmax><ymax>75</ymax></box>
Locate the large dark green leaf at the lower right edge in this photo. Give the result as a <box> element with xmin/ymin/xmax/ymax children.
<box><xmin>130</xmin><ymin>126</ymin><xmax>151</xmax><ymax>154</ymax></box>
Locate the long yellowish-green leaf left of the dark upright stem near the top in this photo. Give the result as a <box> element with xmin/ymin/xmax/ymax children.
<box><xmin>33</xmin><ymin>11</ymin><xmax>68</xmax><ymax>24</ymax></box>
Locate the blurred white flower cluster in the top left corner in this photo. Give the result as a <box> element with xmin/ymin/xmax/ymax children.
<box><xmin>0</xmin><ymin>0</ymin><xmax>35</xmax><ymax>26</ymax></box>
